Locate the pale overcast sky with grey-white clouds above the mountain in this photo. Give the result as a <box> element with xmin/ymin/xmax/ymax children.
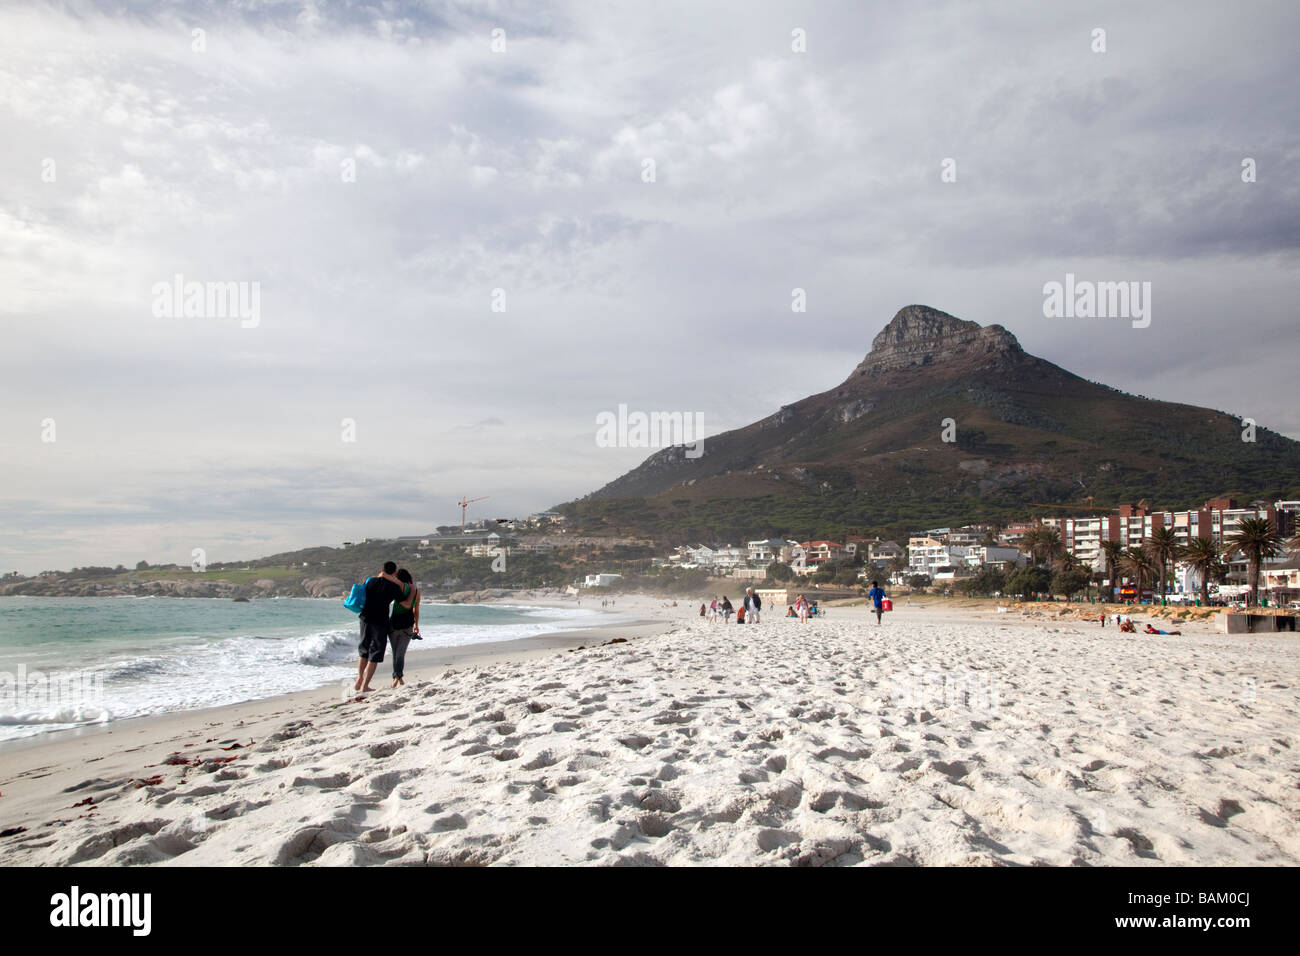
<box><xmin>0</xmin><ymin>0</ymin><xmax>1300</xmax><ymax>574</ymax></box>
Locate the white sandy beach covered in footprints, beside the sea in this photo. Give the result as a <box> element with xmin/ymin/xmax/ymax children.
<box><xmin>0</xmin><ymin>598</ymin><xmax>1300</xmax><ymax>865</ymax></box>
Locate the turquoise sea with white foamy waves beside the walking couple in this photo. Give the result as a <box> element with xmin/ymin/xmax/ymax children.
<box><xmin>0</xmin><ymin>597</ymin><xmax>608</xmax><ymax>741</ymax></box>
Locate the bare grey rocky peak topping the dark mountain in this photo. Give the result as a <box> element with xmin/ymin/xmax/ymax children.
<box><xmin>854</xmin><ymin>306</ymin><xmax>1022</xmax><ymax>376</ymax></box>
